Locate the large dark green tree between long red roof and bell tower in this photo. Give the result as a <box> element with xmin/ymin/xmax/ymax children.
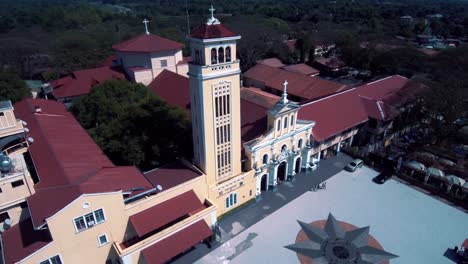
<box><xmin>71</xmin><ymin>80</ymin><xmax>192</xmax><ymax>170</ymax></box>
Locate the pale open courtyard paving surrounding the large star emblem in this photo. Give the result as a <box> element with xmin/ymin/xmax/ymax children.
<box><xmin>196</xmin><ymin>167</ymin><xmax>468</xmax><ymax>264</ymax></box>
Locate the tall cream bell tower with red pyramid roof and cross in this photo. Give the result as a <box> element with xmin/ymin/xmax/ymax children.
<box><xmin>188</xmin><ymin>4</ymin><xmax>242</xmax><ymax>186</ymax></box>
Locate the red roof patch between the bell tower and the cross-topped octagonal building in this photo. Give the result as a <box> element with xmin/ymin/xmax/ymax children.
<box><xmin>148</xmin><ymin>70</ymin><xmax>190</xmax><ymax>110</ymax></box>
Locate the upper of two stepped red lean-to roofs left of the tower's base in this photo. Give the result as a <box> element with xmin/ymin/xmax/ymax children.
<box><xmin>130</xmin><ymin>190</ymin><xmax>205</xmax><ymax>237</ymax></box>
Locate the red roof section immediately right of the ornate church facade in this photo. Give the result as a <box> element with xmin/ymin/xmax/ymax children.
<box><xmin>298</xmin><ymin>89</ymin><xmax>368</xmax><ymax>141</ymax></box>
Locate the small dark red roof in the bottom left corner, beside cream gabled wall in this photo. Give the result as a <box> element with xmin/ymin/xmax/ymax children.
<box><xmin>2</xmin><ymin>219</ymin><xmax>52</xmax><ymax>263</ymax></box>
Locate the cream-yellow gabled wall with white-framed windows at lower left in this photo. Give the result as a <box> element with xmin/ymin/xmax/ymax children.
<box><xmin>25</xmin><ymin>192</ymin><xmax>128</xmax><ymax>264</ymax></box>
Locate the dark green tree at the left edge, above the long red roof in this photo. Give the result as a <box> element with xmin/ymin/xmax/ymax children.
<box><xmin>0</xmin><ymin>69</ymin><xmax>31</xmax><ymax>103</ymax></box>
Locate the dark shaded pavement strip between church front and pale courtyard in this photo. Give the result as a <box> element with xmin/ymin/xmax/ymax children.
<box><xmin>173</xmin><ymin>153</ymin><xmax>351</xmax><ymax>264</ymax></box>
